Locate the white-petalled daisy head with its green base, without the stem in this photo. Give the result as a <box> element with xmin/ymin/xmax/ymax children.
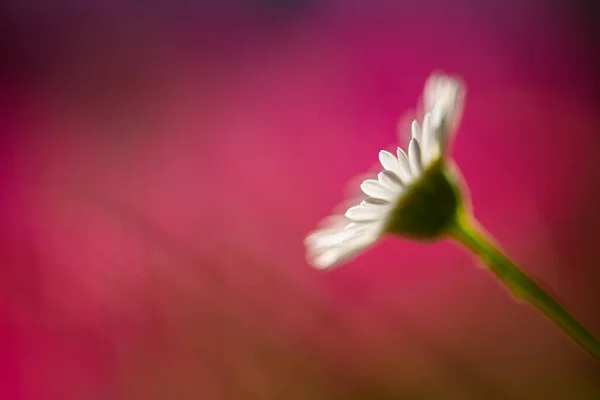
<box><xmin>305</xmin><ymin>75</ymin><xmax>463</xmax><ymax>269</ymax></box>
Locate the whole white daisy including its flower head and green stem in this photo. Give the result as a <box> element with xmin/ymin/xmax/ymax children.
<box><xmin>305</xmin><ymin>71</ymin><xmax>600</xmax><ymax>362</ymax></box>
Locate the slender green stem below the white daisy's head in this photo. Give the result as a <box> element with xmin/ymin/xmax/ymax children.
<box><xmin>450</xmin><ymin>215</ymin><xmax>600</xmax><ymax>362</ymax></box>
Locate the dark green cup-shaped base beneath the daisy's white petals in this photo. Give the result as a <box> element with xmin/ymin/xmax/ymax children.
<box><xmin>386</xmin><ymin>159</ymin><xmax>462</xmax><ymax>240</ymax></box>
